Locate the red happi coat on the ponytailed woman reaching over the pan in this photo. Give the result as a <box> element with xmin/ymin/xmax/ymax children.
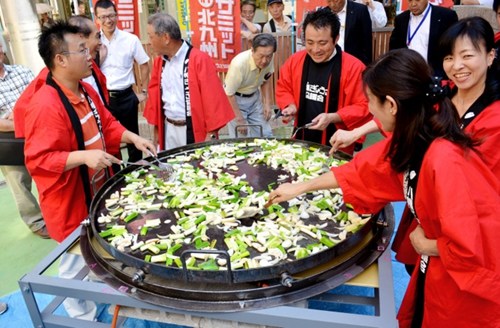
<box><xmin>332</xmin><ymin>138</ymin><xmax>500</xmax><ymax>327</ymax></box>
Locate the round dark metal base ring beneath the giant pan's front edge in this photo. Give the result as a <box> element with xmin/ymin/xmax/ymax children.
<box><xmin>80</xmin><ymin>204</ymin><xmax>394</xmax><ymax>312</ymax></box>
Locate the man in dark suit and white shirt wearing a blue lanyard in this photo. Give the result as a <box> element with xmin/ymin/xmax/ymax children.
<box><xmin>389</xmin><ymin>0</ymin><xmax>458</xmax><ymax>77</ymax></box>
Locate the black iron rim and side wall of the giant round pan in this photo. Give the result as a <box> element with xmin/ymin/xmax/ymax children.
<box><xmin>89</xmin><ymin>138</ymin><xmax>378</xmax><ymax>283</ymax></box>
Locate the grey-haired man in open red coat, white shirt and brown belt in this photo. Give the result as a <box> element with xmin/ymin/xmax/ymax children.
<box><xmin>144</xmin><ymin>13</ymin><xmax>234</xmax><ymax>150</ymax></box>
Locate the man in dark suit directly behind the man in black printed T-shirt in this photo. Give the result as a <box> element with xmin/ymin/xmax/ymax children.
<box><xmin>327</xmin><ymin>0</ymin><xmax>372</xmax><ymax>65</ymax></box>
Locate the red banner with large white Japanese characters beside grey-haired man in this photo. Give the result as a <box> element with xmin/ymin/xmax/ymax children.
<box><xmin>189</xmin><ymin>0</ymin><xmax>241</xmax><ymax>72</ymax></box>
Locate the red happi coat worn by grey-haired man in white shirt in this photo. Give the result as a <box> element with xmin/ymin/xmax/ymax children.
<box><xmin>144</xmin><ymin>48</ymin><xmax>235</xmax><ymax>150</ymax></box>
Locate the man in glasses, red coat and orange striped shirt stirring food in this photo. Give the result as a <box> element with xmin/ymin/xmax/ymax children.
<box><xmin>24</xmin><ymin>22</ymin><xmax>156</xmax><ymax>320</ymax></box>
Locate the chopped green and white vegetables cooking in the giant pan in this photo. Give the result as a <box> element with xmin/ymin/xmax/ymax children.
<box><xmin>98</xmin><ymin>139</ymin><xmax>370</xmax><ymax>270</ymax></box>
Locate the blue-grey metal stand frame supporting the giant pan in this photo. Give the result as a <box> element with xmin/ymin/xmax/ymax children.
<box><xmin>19</xmin><ymin>228</ymin><xmax>397</xmax><ymax>328</ymax></box>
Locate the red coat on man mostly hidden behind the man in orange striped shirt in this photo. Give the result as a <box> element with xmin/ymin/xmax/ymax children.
<box><xmin>14</xmin><ymin>60</ymin><xmax>109</xmax><ymax>138</ymax></box>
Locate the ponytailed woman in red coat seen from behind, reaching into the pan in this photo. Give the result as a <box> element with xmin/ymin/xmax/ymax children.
<box><xmin>269</xmin><ymin>49</ymin><xmax>500</xmax><ymax>327</ymax></box>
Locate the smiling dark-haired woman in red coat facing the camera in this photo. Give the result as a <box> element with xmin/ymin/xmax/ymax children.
<box><xmin>392</xmin><ymin>17</ymin><xmax>500</xmax><ymax>272</ymax></box>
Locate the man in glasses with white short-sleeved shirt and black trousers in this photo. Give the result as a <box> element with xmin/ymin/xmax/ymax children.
<box><xmin>95</xmin><ymin>0</ymin><xmax>149</xmax><ymax>161</ymax></box>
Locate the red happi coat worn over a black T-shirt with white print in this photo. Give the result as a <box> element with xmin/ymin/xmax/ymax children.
<box><xmin>276</xmin><ymin>50</ymin><xmax>373</xmax><ymax>154</ymax></box>
